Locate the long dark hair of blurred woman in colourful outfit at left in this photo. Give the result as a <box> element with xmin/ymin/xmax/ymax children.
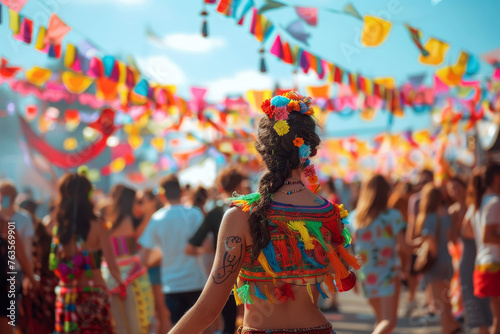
<box><xmin>55</xmin><ymin>173</ymin><xmax>97</xmax><ymax>245</ymax></box>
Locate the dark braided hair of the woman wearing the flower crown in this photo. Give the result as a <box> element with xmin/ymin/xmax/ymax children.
<box><xmin>249</xmin><ymin>107</ymin><xmax>321</xmax><ymax>259</ymax></box>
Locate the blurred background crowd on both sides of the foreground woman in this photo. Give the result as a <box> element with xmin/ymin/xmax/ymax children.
<box><xmin>0</xmin><ymin>165</ymin><xmax>500</xmax><ymax>334</ymax></box>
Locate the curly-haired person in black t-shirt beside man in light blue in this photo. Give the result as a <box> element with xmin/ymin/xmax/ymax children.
<box><xmin>186</xmin><ymin>166</ymin><xmax>247</xmax><ymax>334</ymax></box>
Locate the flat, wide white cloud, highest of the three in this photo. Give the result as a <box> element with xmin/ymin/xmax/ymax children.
<box><xmin>149</xmin><ymin>33</ymin><xmax>227</xmax><ymax>53</ymax></box>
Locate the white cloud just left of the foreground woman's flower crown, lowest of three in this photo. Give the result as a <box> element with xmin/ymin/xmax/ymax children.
<box><xmin>203</xmin><ymin>70</ymin><xmax>275</xmax><ymax>101</ymax></box>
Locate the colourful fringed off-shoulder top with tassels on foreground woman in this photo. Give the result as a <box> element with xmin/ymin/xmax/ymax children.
<box><xmin>230</xmin><ymin>193</ymin><xmax>360</xmax><ymax>304</ymax></box>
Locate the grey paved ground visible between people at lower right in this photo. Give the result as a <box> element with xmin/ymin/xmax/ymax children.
<box><xmin>327</xmin><ymin>292</ymin><xmax>452</xmax><ymax>334</ymax></box>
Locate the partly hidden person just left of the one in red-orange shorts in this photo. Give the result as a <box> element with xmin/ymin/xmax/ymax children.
<box><xmin>459</xmin><ymin>168</ymin><xmax>493</xmax><ymax>334</ymax></box>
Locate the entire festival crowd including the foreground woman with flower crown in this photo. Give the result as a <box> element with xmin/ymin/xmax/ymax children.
<box><xmin>0</xmin><ymin>92</ymin><xmax>500</xmax><ymax>334</ymax></box>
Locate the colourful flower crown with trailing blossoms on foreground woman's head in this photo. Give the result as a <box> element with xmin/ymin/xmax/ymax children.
<box><xmin>261</xmin><ymin>91</ymin><xmax>320</xmax><ymax>193</ymax></box>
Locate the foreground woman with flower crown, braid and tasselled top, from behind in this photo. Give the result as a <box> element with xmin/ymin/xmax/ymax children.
<box><xmin>171</xmin><ymin>92</ymin><xmax>359</xmax><ymax>334</ymax></box>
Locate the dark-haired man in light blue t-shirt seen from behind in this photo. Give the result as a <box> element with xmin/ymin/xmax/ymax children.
<box><xmin>139</xmin><ymin>175</ymin><xmax>207</xmax><ymax>326</ymax></box>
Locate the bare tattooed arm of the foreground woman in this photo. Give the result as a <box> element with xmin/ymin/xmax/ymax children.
<box><xmin>169</xmin><ymin>208</ymin><xmax>250</xmax><ymax>334</ymax></box>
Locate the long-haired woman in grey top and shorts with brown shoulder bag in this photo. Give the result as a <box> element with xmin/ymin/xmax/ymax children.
<box><xmin>413</xmin><ymin>183</ymin><xmax>462</xmax><ymax>334</ymax></box>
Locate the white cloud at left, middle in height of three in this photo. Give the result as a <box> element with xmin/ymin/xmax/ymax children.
<box><xmin>137</xmin><ymin>56</ymin><xmax>187</xmax><ymax>85</ymax></box>
